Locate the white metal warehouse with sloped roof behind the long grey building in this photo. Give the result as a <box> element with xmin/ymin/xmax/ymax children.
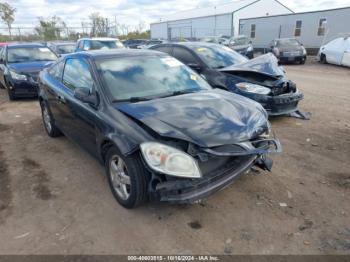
<box><xmin>151</xmin><ymin>0</ymin><xmax>293</xmax><ymax>39</ymax></box>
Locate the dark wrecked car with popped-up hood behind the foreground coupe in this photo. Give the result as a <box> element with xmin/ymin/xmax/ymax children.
<box><xmin>150</xmin><ymin>42</ymin><xmax>303</xmax><ymax>115</ymax></box>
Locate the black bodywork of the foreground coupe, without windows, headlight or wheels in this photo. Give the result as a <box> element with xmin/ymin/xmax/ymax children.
<box><xmin>39</xmin><ymin>50</ymin><xmax>281</xmax><ymax>205</ymax></box>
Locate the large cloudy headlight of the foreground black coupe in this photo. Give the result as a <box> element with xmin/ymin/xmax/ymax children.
<box><xmin>141</xmin><ymin>142</ymin><xmax>202</xmax><ymax>178</ymax></box>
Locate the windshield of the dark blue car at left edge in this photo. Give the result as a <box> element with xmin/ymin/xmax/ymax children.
<box><xmin>7</xmin><ymin>47</ymin><xmax>57</xmax><ymax>63</ymax></box>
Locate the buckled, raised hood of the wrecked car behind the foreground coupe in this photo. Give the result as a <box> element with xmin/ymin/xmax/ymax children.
<box><xmin>219</xmin><ymin>53</ymin><xmax>285</xmax><ymax>77</ymax></box>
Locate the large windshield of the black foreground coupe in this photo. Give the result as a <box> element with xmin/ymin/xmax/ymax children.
<box><xmin>97</xmin><ymin>56</ymin><xmax>211</xmax><ymax>102</ymax></box>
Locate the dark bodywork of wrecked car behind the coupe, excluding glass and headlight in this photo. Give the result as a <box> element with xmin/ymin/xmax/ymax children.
<box><xmin>151</xmin><ymin>43</ymin><xmax>303</xmax><ymax>116</ymax></box>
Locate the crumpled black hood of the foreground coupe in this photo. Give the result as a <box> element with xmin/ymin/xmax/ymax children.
<box><xmin>115</xmin><ymin>89</ymin><xmax>268</xmax><ymax>147</ymax></box>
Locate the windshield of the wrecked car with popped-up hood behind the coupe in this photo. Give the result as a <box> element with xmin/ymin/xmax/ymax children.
<box><xmin>192</xmin><ymin>45</ymin><xmax>248</xmax><ymax>69</ymax></box>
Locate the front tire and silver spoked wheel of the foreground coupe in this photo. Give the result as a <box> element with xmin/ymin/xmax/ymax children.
<box><xmin>105</xmin><ymin>146</ymin><xmax>149</xmax><ymax>209</ymax></box>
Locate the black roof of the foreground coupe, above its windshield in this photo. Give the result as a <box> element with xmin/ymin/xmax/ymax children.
<box><xmin>65</xmin><ymin>49</ymin><xmax>167</xmax><ymax>60</ymax></box>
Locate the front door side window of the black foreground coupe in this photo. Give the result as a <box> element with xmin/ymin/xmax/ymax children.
<box><xmin>63</xmin><ymin>59</ymin><xmax>94</xmax><ymax>90</ymax></box>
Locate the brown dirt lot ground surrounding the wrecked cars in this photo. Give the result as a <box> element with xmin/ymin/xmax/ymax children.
<box><xmin>0</xmin><ymin>58</ymin><xmax>350</xmax><ymax>254</ymax></box>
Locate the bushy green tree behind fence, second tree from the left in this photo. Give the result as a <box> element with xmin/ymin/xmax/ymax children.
<box><xmin>35</xmin><ymin>16</ymin><xmax>66</xmax><ymax>40</ymax></box>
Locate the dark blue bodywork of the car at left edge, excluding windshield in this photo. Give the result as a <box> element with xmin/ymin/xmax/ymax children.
<box><xmin>0</xmin><ymin>44</ymin><xmax>57</xmax><ymax>97</ymax></box>
